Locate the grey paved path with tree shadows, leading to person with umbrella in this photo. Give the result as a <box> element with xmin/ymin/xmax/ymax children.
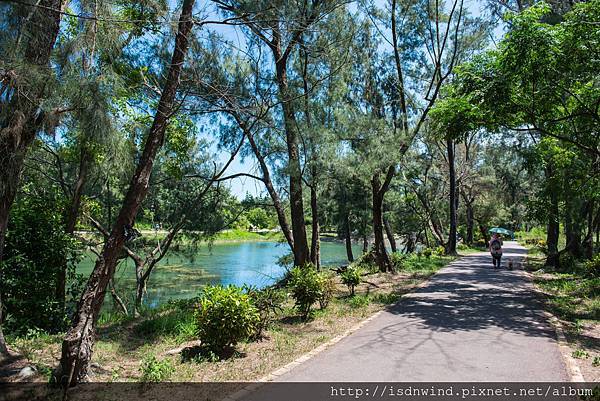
<box><xmin>278</xmin><ymin>241</ymin><xmax>568</xmax><ymax>382</ymax></box>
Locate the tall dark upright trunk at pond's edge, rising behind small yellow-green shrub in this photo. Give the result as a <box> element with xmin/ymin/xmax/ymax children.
<box><xmin>273</xmin><ymin>42</ymin><xmax>310</xmax><ymax>266</ymax></box>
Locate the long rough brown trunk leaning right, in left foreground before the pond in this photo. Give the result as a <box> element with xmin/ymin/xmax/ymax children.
<box><xmin>56</xmin><ymin>0</ymin><xmax>194</xmax><ymax>387</ymax></box>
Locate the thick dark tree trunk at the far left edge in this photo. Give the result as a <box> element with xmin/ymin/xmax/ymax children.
<box><xmin>0</xmin><ymin>0</ymin><xmax>62</xmax><ymax>354</ymax></box>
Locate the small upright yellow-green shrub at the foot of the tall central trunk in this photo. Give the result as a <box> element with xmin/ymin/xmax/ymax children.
<box><xmin>289</xmin><ymin>264</ymin><xmax>324</xmax><ymax>319</ymax></box>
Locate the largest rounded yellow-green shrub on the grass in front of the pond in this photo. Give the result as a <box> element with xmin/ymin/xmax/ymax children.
<box><xmin>196</xmin><ymin>285</ymin><xmax>260</xmax><ymax>352</ymax></box>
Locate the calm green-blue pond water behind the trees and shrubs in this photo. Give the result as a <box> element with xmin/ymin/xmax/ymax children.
<box><xmin>77</xmin><ymin>241</ymin><xmax>360</xmax><ymax>308</ymax></box>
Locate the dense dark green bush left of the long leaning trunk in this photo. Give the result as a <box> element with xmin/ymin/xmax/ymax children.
<box><xmin>2</xmin><ymin>189</ymin><xmax>81</xmax><ymax>334</ymax></box>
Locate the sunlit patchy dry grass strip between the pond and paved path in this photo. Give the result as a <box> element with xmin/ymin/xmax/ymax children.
<box><xmin>11</xmin><ymin>256</ymin><xmax>452</xmax><ymax>388</ymax></box>
